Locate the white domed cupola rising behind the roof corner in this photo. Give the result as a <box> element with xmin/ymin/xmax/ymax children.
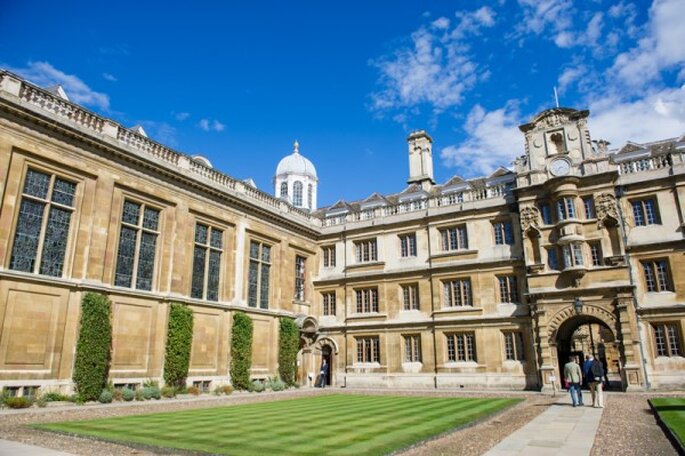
<box><xmin>274</xmin><ymin>141</ymin><xmax>319</xmax><ymax>211</ymax></box>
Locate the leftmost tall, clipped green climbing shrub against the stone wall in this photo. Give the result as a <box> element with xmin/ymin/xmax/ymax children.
<box><xmin>74</xmin><ymin>293</ymin><xmax>112</xmax><ymax>401</ymax></box>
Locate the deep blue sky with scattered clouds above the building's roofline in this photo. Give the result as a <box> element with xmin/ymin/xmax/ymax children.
<box><xmin>0</xmin><ymin>0</ymin><xmax>685</xmax><ymax>206</ymax></box>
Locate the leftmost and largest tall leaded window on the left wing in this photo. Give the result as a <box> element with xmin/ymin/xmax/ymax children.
<box><xmin>10</xmin><ymin>169</ymin><xmax>76</xmax><ymax>277</ymax></box>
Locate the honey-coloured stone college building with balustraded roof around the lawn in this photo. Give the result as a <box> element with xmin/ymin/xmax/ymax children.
<box><xmin>0</xmin><ymin>71</ymin><xmax>685</xmax><ymax>394</ymax></box>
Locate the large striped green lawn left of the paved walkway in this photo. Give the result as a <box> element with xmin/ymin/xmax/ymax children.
<box><xmin>36</xmin><ymin>394</ymin><xmax>520</xmax><ymax>456</ymax></box>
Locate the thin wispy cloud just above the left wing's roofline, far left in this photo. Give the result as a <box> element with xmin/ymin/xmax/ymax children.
<box><xmin>8</xmin><ymin>62</ymin><xmax>109</xmax><ymax>111</ymax></box>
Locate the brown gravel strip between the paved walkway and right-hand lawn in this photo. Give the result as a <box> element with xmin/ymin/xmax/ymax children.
<box><xmin>590</xmin><ymin>393</ymin><xmax>677</xmax><ymax>456</ymax></box>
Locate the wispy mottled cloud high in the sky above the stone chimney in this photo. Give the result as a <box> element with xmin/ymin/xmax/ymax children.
<box><xmin>371</xmin><ymin>7</ymin><xmax>494</xmax><ymax>113</ymax></box>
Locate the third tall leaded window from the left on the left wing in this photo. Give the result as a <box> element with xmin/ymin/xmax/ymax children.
<box><xmin>190</xmin><ymin>223</ymin><xmax>223</xmax><ymax>301</ymax></box>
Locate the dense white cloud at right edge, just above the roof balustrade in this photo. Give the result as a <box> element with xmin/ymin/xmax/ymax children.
<box><xmin>588</xmin><ymin>85</ymin><xmax>685</xmax><ymax>147</ymax></box>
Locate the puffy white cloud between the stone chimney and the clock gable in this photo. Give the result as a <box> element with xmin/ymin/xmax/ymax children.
<box><xmin>440</xmin><ymin>101</ymin><xmax>523</xmax><ymax>177</ymax></box>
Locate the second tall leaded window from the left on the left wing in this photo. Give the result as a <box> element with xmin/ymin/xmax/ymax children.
<box><xmin>114</xmin><ymin>199</ymin><xmax>160</xmax><ymax>290</ymax></box>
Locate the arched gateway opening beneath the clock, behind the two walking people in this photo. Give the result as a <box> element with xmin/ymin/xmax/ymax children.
<box><xmin>554</xmin><ymin>315</ymin><xmax>621</xmax><ymax>389</ymax></box>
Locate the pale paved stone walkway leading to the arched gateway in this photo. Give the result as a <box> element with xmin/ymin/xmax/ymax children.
<box><xmin>485</xmin><ymin>394</ymin><xmax>606</xmax><ymax>456</ymax></box>
